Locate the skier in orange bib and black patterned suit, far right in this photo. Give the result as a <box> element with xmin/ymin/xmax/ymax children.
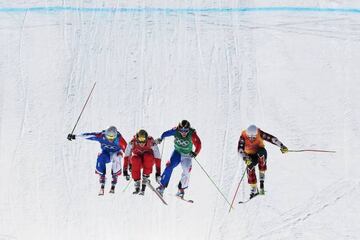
<box><xmin>238</xmin><ymin>125</ymin><xmax>288</xmax><ymax>199</ymax></box>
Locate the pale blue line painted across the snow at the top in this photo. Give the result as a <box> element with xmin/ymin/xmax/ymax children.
<box><xmin>0</xmin><ymin>6</ymin><xmax>360</xmax><ymax>14</ymax></box>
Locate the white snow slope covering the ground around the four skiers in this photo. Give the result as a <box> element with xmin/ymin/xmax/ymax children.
<box><xmin>0</xmin><ymin>0</ymin><xmax>360</xmax><ymax>240</ymax></box>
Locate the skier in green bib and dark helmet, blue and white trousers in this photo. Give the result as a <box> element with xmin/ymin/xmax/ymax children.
<box><xmin>156</xmin><ymin>120</ymin><xmax>201</xmax><ymax>198</ymax></box>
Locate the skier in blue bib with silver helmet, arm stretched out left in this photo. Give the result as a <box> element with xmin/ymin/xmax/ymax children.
<box><xmin>67</xmin><ymin>126</ymin><xmax>127</xmax><ymax>195</ymax></box>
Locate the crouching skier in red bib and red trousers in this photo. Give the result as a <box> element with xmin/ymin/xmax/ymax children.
<box><xmin>123</xmin><ymin>129</ymin><xmax>161</xmax><ymax>195</ymax></box>
